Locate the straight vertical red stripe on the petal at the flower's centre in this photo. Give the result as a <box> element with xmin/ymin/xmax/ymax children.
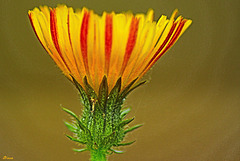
<box><xmin>105</xmin><ymin>14</ymin><xmax>113</xmax><ymax>73</ymax></box>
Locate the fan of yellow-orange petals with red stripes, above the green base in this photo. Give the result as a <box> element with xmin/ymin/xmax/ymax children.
<box><xmin>28</xmin><ymin>5</ymin><xmax>192</xmax><ymax>92</ymax></box>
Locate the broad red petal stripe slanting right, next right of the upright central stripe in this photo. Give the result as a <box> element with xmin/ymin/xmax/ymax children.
<box><xmin>121</xmin><ymin>17</ymin><xmax>139</xmax><ymax>73</ymax></box>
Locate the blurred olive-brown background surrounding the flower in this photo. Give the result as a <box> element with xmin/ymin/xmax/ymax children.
<box><xmin>0</xmin><ymin>0</ymin><xmax>240</xmax><ymax>161</ymax></box>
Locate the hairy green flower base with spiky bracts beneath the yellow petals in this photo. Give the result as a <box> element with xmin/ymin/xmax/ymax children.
<box><xmin>63</xmin><ymin>76</ymin><xmax>145</xmax><ymax>160</ymax></box>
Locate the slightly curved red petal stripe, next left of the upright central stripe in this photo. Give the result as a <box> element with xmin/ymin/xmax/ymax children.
<box><xmin>80</xmin><ymin>11</ymin><xmax>90</xmax><ymax>72</ymax></box>
